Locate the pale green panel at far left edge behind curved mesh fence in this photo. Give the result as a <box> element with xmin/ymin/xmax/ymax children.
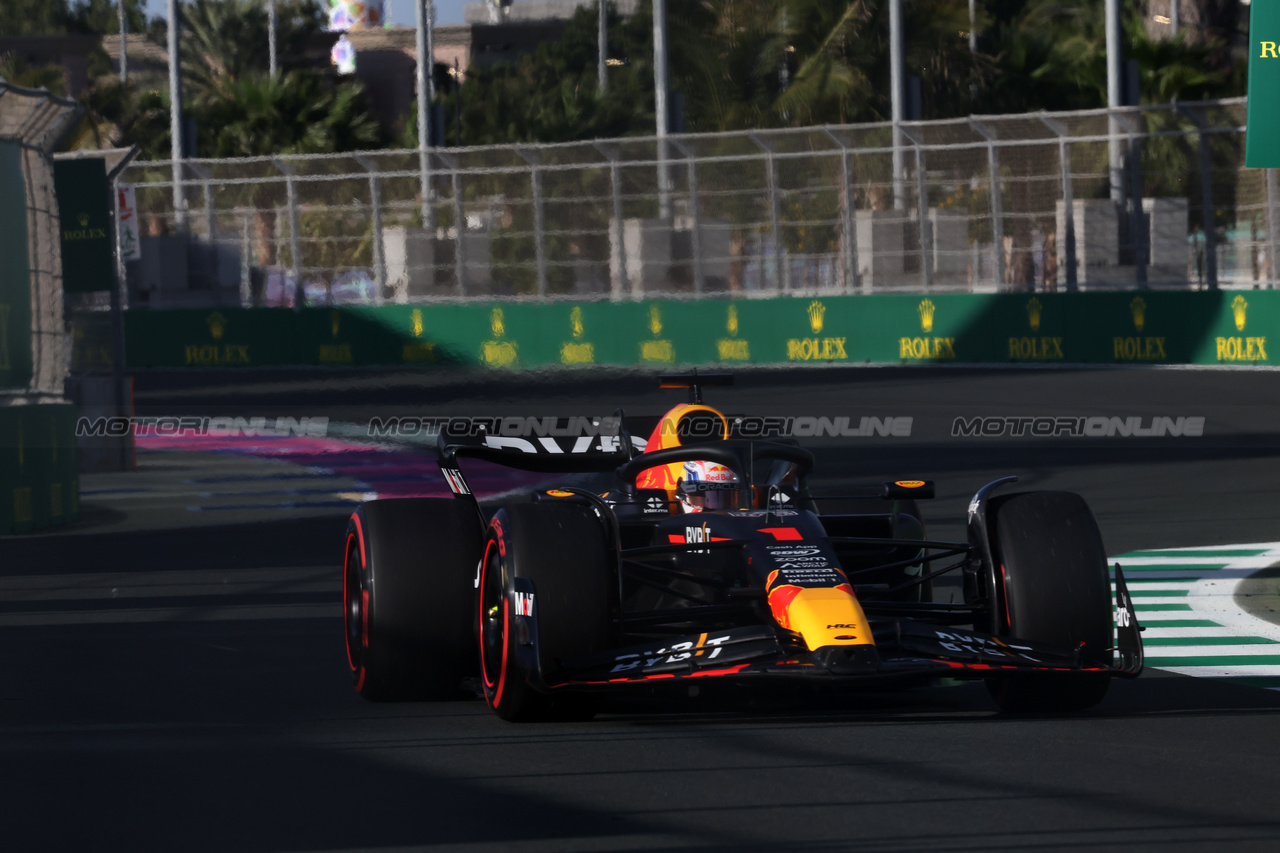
<box><xmin>0</xmin><ymin>140</ymin><xmax>31</xmax><ymax>388</ymax></box>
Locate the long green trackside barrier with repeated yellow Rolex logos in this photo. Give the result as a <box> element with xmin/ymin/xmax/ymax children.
<box><xmin>125</xmin><ymin>291</ymin><xmax>1280</xmax><ymax>369</ymax></box>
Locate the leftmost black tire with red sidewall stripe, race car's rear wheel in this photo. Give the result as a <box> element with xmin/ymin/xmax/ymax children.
<box><xmin>342</xmin><ymin>498</ymin><xmax>483</xmax><ymax>702</ymax></box>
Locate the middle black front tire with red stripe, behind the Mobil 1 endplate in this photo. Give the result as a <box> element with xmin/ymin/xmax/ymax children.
<box><xmin>477</xmin><ymin>503</ymin><xmax>616</xmax><ymax>722</ymax></box>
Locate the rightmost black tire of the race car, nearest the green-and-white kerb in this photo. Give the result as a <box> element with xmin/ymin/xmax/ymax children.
<box><xmin>987</xmin><ymin>492</ymin><xmax>1114</xmax><ymax>713</ymax></box>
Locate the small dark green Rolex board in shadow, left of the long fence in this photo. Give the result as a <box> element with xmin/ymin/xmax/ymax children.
<box><xmin>54</xmin><ymin>158</ymin><xmax>115</xmax><ymax>293</ymax></box>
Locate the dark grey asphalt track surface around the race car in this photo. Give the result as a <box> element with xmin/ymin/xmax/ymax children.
<box><xmin>0</xmin><ymin>368</ymin><xmax>1280</xmax><ymax>852</ymax></box>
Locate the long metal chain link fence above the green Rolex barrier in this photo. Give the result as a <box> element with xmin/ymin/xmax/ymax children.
<box><xmin>120</xmin><ymin>99</ymin><xmax>1280</xmax><ymax>307</ymax></box>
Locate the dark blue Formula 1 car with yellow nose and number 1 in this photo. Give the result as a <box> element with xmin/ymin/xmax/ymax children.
<box><xmin>343</xmin><ymin>371</ymin><xmax>1143</xmax><ymax>720</ymax></box>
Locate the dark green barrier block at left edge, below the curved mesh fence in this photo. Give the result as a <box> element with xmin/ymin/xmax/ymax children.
<box><xmin>0</xmin><ymin>403</ymin><xmax>79</xmax><ymax>534</ymax></box>
